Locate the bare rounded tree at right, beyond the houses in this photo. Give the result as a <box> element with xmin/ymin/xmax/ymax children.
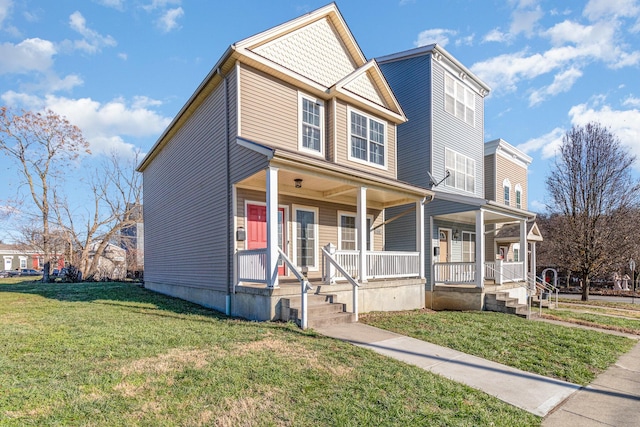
<box><xmin>545</xmin><ymin>123</ymin><xmax>640</xmax><ymax>301</ymax></box>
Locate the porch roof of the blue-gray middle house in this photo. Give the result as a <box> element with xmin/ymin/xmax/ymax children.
<box><xmin>434</xmin><ymin>191</ymin><xmax>536</xmax><ymax>224</ymax></box>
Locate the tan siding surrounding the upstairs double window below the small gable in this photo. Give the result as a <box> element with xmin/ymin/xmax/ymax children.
<box><xmin>336</xmin><ymin>101</ymin><xmax>396</xmax><ymax>179</ymax></box>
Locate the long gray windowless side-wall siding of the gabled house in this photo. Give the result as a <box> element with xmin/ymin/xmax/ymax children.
<box><xmin>144</xmin><ymin>80</ymin><xmax>228</xmax><ymax>291</ymax></box>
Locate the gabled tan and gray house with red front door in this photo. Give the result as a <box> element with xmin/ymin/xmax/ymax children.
<box><xmin>138</xmin><ymin>4</ymin><xmax>433</xmax><ymax>320</ymax></box>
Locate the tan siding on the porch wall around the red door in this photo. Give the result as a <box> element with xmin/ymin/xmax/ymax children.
<box><xmin>236</xmin><ymin>189</ymin><xmax>384</xmax><ymax>278</ymax></box>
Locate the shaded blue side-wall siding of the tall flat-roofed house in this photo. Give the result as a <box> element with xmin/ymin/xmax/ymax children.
<box><xmin>380</xmin><ymin>56</ymin><xmax>431</xmax><ymax>188</ymax></box>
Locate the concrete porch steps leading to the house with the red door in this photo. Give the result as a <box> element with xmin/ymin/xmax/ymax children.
<box><xmin>281</xmin><ymin>294</ymin><xmax>354</xmax><ymax>328</ymax></box>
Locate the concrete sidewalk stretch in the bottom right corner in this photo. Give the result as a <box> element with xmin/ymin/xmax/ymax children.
<box><xmin>542</xmin><ymin>343</ymin><xmax>640</xmax><ymax>427</ymax></box>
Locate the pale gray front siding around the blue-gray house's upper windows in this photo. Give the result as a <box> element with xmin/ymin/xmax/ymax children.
<box><xmin>431</xmin><ymin>61</ymin><xmax>484</xmax><ymax>197</ymax></box>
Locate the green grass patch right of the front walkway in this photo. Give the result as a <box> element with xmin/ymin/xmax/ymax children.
<box><xmin>360</xmin><ymin>310</ymin><xmax>636</xmax><ymax>385</ymax></box>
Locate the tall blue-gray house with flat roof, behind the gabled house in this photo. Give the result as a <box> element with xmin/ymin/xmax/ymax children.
<box><xmin>378</xmin><ymin>44</ymin><xmax>535</xmax><ymax>310</ymax></box>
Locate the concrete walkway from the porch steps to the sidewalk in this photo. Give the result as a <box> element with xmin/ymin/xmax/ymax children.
<box><xmin>316</xmin><ymin>323</ymin><xmax>580</xmax><ymax>418</ymax></box>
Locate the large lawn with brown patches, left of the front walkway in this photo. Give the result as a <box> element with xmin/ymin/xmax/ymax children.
<box><xmin>0</xmin><ymin>279</ymin><xmax>540</xmax><ymax>426</ymax></box>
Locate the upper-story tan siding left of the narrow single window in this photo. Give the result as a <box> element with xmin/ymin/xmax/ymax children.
<box><xmin>240</xmin><ymin>65</ymin><xmax>298</xmax><ymax>150</ymax></box>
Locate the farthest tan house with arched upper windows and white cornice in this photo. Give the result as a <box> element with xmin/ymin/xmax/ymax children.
<box><xmin>484</xmin><ymin>139</ymin><xmax>543</xmax><ymax>273</ymax></box>
